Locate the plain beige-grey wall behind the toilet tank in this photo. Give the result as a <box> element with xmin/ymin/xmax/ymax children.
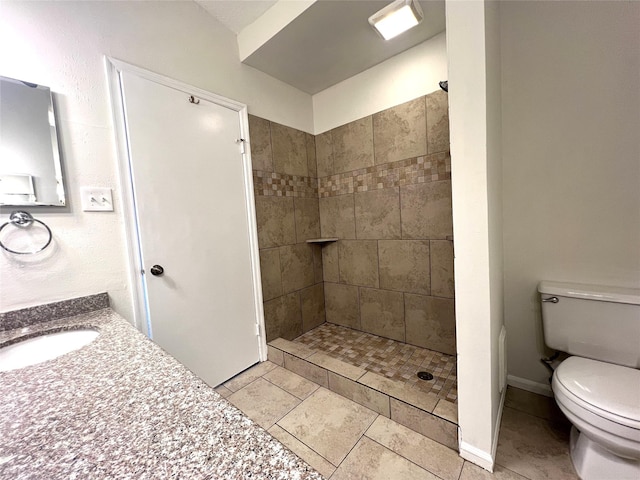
<box><xmin>501</xmin><ymin>1</ymin><xmax>640</xmax><ymax>391</ymax></box>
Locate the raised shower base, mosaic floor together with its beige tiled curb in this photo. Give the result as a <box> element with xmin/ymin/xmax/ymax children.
<box><xmin>268</xmin><ymin>323</ymin><xmax>458</xmax><ymax>450</ymax></box>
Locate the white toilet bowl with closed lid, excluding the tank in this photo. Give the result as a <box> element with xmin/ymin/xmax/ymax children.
<box><xmin>552</xmin><ymin>357</ymin><xmax>640</xmax><ymax>480</ymax></box>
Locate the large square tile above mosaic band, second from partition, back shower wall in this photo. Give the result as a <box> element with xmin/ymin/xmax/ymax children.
<box><xmin>373</xmin><ymin>97</ymin><xmax>427</xmax><ymax>165</ymax></box>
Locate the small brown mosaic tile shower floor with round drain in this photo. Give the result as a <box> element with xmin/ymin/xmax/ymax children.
<box><xmin>294</xmin><ymin>323</ymin><xmax>458</xmax><ymax>404</ymax></box>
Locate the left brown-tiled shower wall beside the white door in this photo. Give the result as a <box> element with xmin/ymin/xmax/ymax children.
<box><xmin>249</xmin><ymin>115</ymin><xmax>325</xmax><ymax>341</ymax></box>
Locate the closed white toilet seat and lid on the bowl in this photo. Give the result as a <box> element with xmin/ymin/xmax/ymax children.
<box><xmin>553</xmin><ymin>357</ymin><xmax>640</xmax><ymax>430</ymax></box>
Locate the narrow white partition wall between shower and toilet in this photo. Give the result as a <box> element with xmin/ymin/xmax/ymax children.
<box><xmin>446</xmin><ymin>0</ymin><xmax>504</xmax><ymax>464</ymax></box>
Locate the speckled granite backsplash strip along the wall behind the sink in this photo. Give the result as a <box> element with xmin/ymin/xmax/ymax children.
<box><xmin>0</xmin><ymin>293</ymin><xmax>109</xmax><ymax>331</ymax></box>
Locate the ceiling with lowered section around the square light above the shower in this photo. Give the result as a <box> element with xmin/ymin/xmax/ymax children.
<box><xmin>196</xmin><ymin>0</ymin><xmax>445</xmax><ymax>94</ymax></box>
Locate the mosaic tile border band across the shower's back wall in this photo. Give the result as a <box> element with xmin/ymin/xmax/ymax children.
<box><xmin>318</xmin><ymin>152</ymin><xmax>451</xmax><ymax>198</ymax></box>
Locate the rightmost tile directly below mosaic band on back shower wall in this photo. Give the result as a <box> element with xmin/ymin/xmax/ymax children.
<box><xmin>400</xmin><ymin>180</ymin><xmax>453</xmax><ymax>239</ymax></box>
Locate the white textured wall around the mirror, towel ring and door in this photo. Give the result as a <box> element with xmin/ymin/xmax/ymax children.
<box><xmin>0</xmin><ymin>0</ymin><xmax>313</xmax><ymax>319</ymax></box>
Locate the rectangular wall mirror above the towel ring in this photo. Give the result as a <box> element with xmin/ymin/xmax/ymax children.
<box><xmin>0</xmin><ymin>77</ymin><xmax>65</xmax><ymax>206</ymax></box>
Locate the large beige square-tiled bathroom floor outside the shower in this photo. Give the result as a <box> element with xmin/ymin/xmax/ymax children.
<box><xmin>221</xmin><ymin>362</ymin><xmax>578</xmax><ymax>480</ymax></box>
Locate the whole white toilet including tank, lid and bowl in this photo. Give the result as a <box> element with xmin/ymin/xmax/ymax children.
<box><xmin>538</xmin><ymin>281</ymin><xmax>640</xmax><ymax>480</ymax></box>
